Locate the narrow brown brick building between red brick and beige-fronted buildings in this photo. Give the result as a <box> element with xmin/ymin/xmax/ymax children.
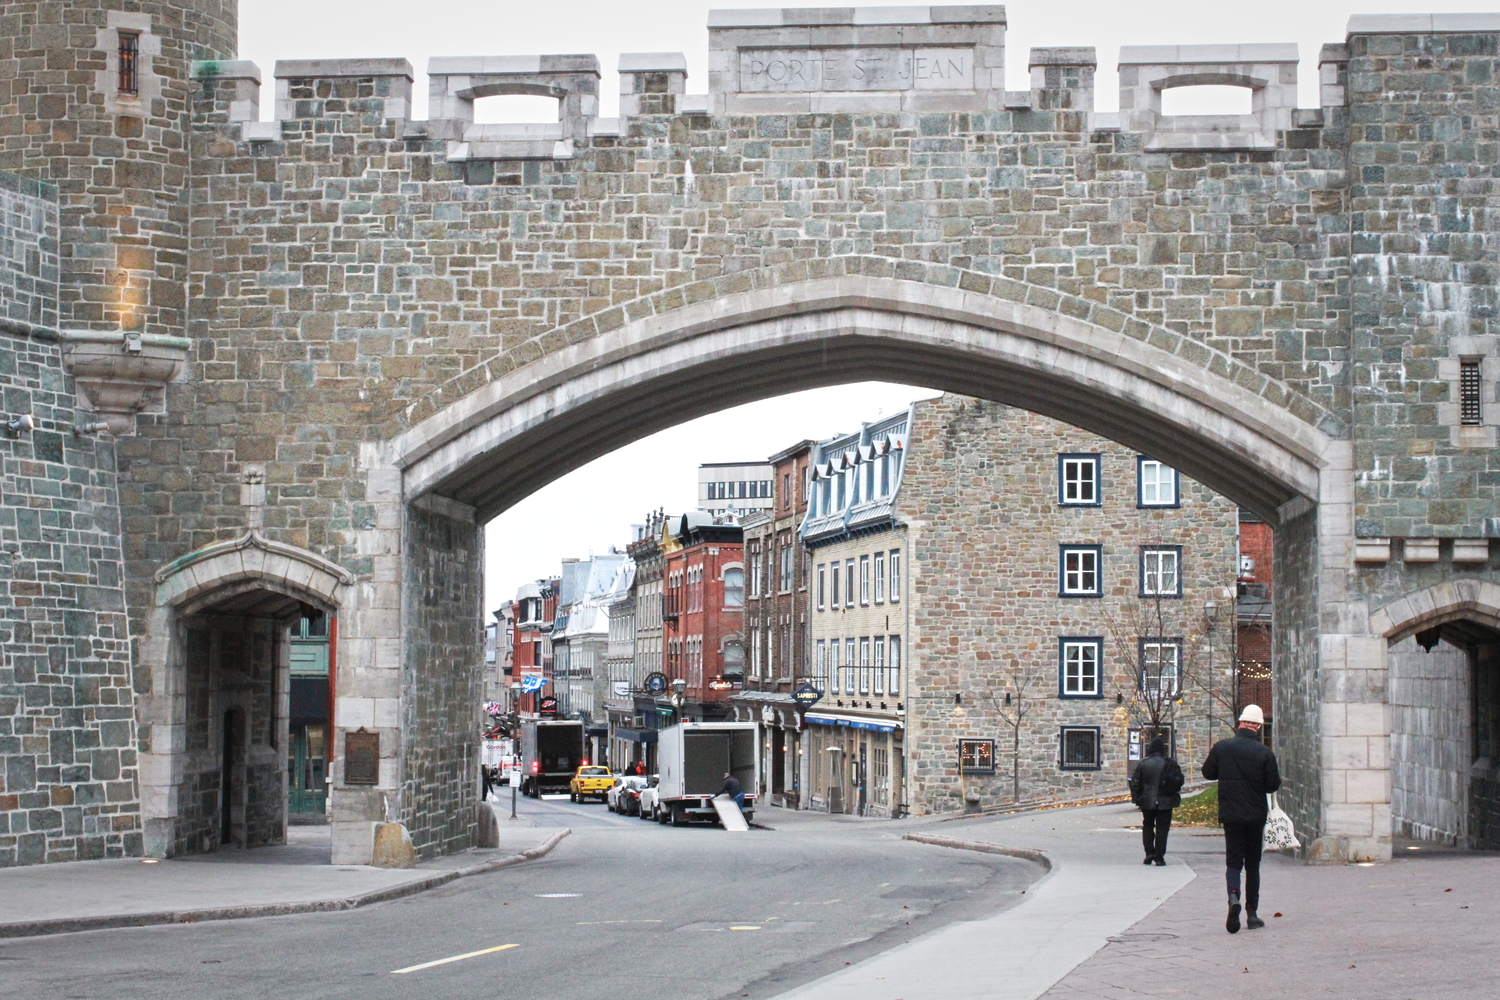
<box><xmin>731</xmin><ymin>441</ymin><xmax>815</xmax><ymax>808</ymax></box>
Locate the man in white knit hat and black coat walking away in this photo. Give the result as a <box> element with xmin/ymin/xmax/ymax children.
<box><xmin>1203</xmin><ymin>705</ymin><xmax>1281</xmax><ymax>934</ymax></box>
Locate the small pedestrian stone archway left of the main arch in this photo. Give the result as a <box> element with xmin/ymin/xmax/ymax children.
<box><xmin>140</xmin><ymin>529</ymin><xmax>356</xmax><ymax>856</ymax></box>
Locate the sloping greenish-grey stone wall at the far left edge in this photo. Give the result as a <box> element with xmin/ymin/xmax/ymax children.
<box><xmin>0</xmin><ymin>174</ymin><xmax>141</xmax><ymax>867</ymax></box>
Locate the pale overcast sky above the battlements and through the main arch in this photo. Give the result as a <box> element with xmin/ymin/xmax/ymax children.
<box><xmin>231</xmin><ymin>0</ymin><xmax>1496</xmax><ymax>610</ymax></box>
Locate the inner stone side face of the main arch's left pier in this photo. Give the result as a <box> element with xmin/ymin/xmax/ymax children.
<box><xmin>393</xmin><ymin>501</ymin><xmax>485</xmax><ymax>858</ymax></box>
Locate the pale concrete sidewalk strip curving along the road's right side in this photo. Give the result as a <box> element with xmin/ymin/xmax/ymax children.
<box><xmin>777</xmin><ymin>804</ymin><xmax>1196</xmax><ymax>1000</ymax></box>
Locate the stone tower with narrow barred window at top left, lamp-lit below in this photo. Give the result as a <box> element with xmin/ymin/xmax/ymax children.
<box><xmin>0</xmin><ymin>0</ymin><xmax>239</xmax><ymax>337</ymax></box>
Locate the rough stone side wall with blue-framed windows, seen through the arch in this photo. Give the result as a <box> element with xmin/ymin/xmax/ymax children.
<box><xmin>897</xmin><ymin>394</ymin><xmax>1238</xmax><ymax>813</ymax></box>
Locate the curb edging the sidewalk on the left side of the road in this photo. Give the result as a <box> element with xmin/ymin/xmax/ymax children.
<box><xmin>0</xmin><ymin>829</ymin><xmax>573</xmax><ymax>939</ymax></box>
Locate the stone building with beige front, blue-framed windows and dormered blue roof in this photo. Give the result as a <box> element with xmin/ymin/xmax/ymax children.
<box><xmin>801</xmin><ymin>394</ymin><xmax>1238</xmax><ymax>816</ymax></box>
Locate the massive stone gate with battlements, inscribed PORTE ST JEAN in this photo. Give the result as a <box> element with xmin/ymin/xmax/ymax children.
<box><xmin>0</xmin><ymin>0</ymin><xmax>1500</xmax><ymax>864</ymax></box>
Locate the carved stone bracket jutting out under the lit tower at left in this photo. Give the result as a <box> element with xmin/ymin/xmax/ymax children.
<box><xmin>62</xmin><ymin>330</ymin><xmax>192</xmax><ymax>436</ymax></box>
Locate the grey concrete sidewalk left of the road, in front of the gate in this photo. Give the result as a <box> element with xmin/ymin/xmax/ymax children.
<box><xmin>0</xmin><ymin>823</ymin><xmax>567</xmax><ymax>939</ymax></box>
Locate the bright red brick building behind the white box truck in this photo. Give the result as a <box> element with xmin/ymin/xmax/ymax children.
<box><xmin>662</xmin><ymin>511</ymin><xmax>746</xmax><ymax>721</ymax></box>
